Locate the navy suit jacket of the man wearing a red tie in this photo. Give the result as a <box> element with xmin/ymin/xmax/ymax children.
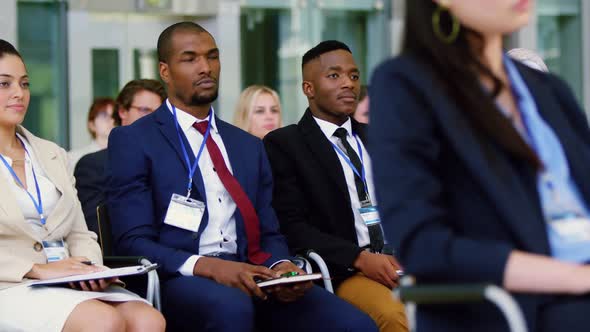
<box><xmin>107</xmin><ymin>103</ymin><xmax>289</xmax><ymax>276</ymax></box>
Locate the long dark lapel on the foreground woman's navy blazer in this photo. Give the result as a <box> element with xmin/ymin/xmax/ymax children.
<box><xmin>405</xmin><ymin>59</ymin><xmax>549</xmax><ymax>253</ymax></box>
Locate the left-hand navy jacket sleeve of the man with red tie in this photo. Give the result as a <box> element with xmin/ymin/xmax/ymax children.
<box><xmin>107</xmin><ymin>127</ymin><xmax>192</xmax><ymax>274</ymax></box>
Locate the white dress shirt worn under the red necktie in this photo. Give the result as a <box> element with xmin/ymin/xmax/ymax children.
<box><xmin>166</xmin><ymin>99</ymin><xmax>238</xmax><ymax>276</ymax></box>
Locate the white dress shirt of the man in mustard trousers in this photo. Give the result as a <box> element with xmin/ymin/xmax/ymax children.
<box><xmin>313</xmin><ymin>116</ymin><xmax>377</xmax><ymax>247</ymax></box>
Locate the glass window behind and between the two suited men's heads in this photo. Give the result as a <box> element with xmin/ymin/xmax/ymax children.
<box><xmin>241</xmin><ymin>0</ymin><xmax>391</xmax><ymax>125</ymax></box>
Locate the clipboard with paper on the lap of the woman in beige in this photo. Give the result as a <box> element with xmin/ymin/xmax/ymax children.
<box><xmin>29</xmin><ymin>264</ymin><xmax>158</xmax><ymax>287</ymax></box>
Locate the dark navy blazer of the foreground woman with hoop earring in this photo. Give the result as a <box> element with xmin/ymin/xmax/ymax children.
<box><xmin>369</xmin><ymin>55</ymin><xmax>590</xmax><ymax>331</ymax></box>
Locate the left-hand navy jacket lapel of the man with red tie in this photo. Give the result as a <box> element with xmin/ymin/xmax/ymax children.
<box><xmin>154</xmin><ymin>103</ymin><xmax>207</xmax><ymax>201</ymax></box>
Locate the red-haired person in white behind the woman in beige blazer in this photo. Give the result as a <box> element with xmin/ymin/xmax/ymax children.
<box><xmin>68</xmin><ymin>98</ymin><xmax>115</xmax><ymax>172</ymax></box>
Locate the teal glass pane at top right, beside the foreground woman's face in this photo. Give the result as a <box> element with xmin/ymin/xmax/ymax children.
<box><xmin>537</xmin><ymin>0</ymin><xmax>583</xmax><ymax>104</ymax></box>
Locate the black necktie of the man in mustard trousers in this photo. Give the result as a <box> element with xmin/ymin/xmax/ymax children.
<box><xmin>334</xmin><ymin>128</ymin><xmax>384</xmax><ymax>252</ymax></box>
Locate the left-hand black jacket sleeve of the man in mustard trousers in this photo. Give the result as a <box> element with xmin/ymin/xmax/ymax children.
<box><xmin>264</xmin><ymin>133</ymin><xmax>362</xmax><ymax>267</ymax></box>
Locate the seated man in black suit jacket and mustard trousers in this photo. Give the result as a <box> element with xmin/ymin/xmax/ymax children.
<box><xmin>264</xmin><ymin>41</ymin><xmax>407</xmax><ymax>331</ymax></box>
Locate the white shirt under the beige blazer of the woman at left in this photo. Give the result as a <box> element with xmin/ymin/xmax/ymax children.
<box><xmin>0</xmin><ymin>134</ymin><xmax>61</xmax><ymax>233</ymax></box>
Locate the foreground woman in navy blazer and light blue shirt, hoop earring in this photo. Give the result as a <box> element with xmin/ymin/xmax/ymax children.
<box><xmin>369</xmin><ymin>0</ymin><xmax>590</xmax><ymax>331</ymax></box>
